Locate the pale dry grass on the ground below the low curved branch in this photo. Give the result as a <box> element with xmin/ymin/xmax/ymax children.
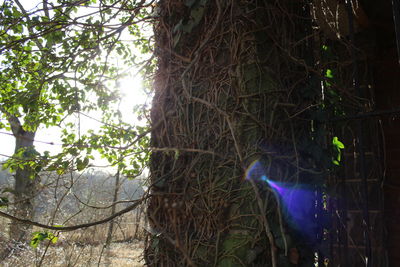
<box><xmin>0</xmin><ymin>214</ymin><xmax>145</xmax><ymax>267</ymax></box>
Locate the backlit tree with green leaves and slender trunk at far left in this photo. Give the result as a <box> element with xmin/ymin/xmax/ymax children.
<box><xmin>0</xmin><ymin>0</ymin><xmax>151</xmax><ymax>246</ymax></box>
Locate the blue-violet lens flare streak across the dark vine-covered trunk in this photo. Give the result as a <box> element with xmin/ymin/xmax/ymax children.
<box><xmin>246</xmin><ymin>161</ymin><xmax>317</xmax><ymax>242</ymax></box>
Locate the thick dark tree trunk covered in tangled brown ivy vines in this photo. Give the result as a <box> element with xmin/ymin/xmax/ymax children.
<box><xmin>145</xmin><ymin>0</ymin><xmax>323</xmax><ymax>266</ymax></box>
